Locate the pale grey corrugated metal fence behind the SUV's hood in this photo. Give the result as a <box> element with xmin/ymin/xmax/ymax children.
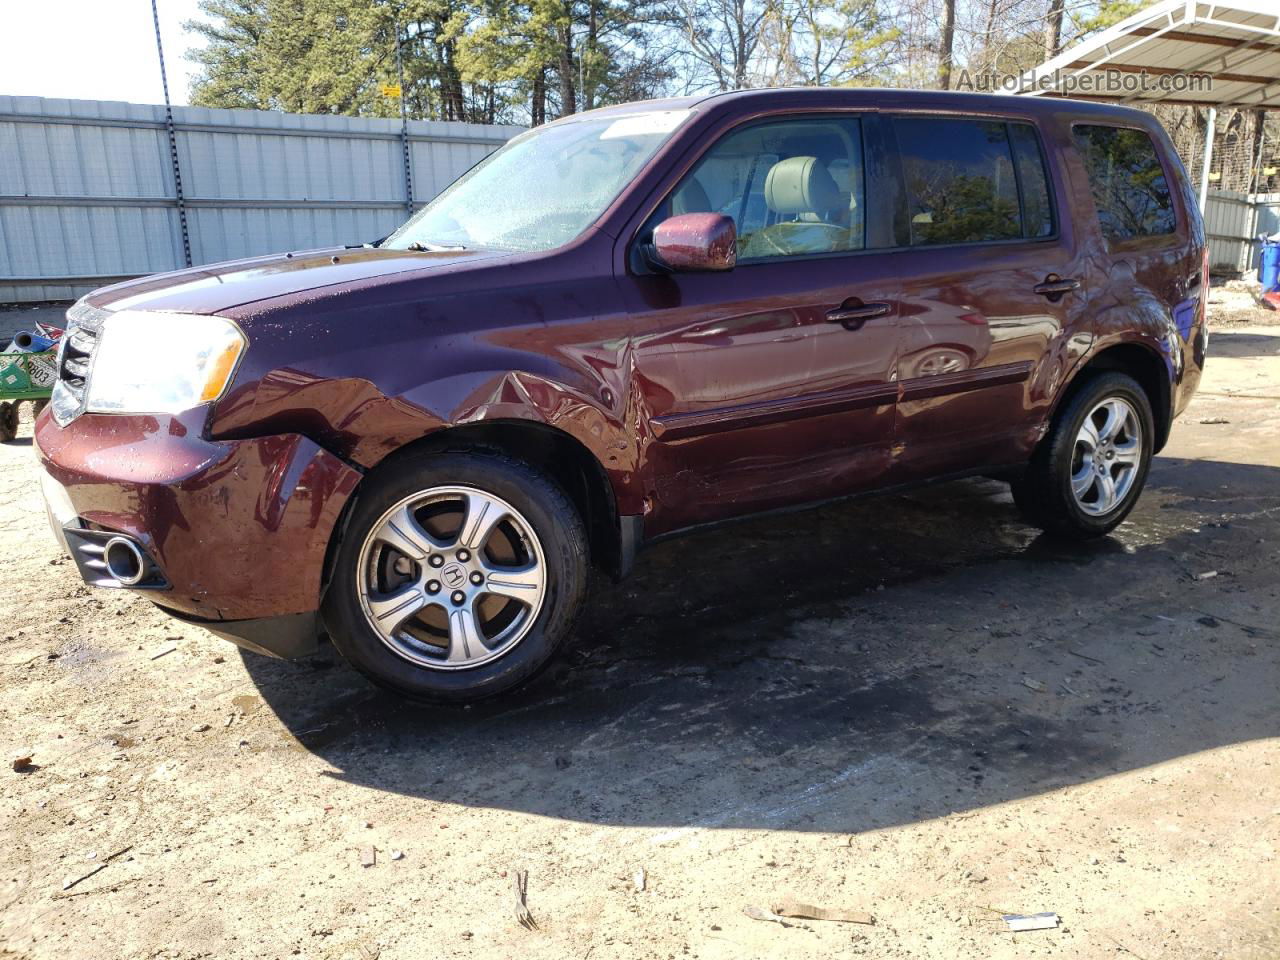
<box><xmin>0</xmin><ymin>96</ymin><xmax>522</xmax><ymax>303</ymax></box>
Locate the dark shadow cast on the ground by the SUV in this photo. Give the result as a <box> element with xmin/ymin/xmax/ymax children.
<box><xmin>244</xmin><ymin>458</ymin><xmax>1280</xmax><ymax>832</ymax></box>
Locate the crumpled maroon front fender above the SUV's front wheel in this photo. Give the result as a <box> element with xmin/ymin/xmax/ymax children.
<box><xmin>210</xmin><ymin>243</ymin><xmax>637</xmax><ymax>507</ymax></box>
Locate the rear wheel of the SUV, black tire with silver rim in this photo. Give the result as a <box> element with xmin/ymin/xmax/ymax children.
<box><xmin>1011</xmin><ymin>372</ymin><xmax>1156</xmax><ymax>540</ymax></box>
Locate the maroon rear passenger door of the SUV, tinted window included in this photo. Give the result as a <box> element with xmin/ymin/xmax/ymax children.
<box><xmin>890</xmin><ymin>114</ymin><xmax>1087</xmax><ymax>480</ymax></box>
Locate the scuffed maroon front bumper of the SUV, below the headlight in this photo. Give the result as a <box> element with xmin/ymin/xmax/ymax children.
<box><xmin>36</xmin><ymin>410</ymin><xmax>360</xmax><ymax>655</ymax></box>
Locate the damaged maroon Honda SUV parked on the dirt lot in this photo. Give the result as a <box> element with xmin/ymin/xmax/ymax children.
<box><xmin>36</xmin><ymin>90</ymin><xmax>1207</xmax><ymax>700</ymax></box>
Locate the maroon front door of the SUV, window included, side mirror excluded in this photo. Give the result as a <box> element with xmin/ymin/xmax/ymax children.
<box><xmin>622</xmin><ymin>115</ymin><xmax>899</xmax><ymax>536</ymax></box>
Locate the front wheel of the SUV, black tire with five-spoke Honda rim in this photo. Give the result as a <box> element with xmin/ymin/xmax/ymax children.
<box><xmin>321</xmin><ymin>451</ymin><xmax>589</xmax><ymax>703</ymax></box>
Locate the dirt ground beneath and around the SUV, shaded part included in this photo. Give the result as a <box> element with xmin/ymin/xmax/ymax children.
<box><xmin>0</xmin><ymin>315</ymin><xmax>1280</xmax><ymax>960</ymax></box>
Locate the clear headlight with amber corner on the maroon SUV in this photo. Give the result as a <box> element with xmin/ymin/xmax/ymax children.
<box><xmin>84</xmin><ymin>310</ymin><xmax>247</xmax><ymax>413</ymax></box>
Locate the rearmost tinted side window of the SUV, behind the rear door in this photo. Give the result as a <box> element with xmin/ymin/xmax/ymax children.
<box><xmin>1073</xmin><ymin>125</ymin><xmax>1176</xmax><ymax>241</ymax></box>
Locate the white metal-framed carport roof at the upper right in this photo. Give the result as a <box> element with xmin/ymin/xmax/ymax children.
<box><xmin>1021</xmin><ymin>0</ymin><xmax>1280</xmax><ymax>109</ymax></box>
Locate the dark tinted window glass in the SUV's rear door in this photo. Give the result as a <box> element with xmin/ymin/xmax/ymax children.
<box><xmin>893</xmin><ymin>116</ymin><xmax>1024</xmax><ymax>247</ymax></box>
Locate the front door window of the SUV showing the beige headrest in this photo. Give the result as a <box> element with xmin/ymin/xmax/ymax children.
<box><xmin>663</xmin><ymin>118</ymin><xmax>867</xmax><ymax>260</ymax></box>
